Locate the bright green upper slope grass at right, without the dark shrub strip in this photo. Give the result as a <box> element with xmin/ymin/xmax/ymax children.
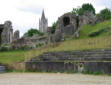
<box><xmin>79</xmin><ymin>20</ymin><xmax>111</xmax><ymax>39</ymax></box>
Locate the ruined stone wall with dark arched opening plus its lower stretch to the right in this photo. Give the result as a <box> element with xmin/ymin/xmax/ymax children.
<box><xmin>54</xmin><ymin>11</ymin><xmax>96</xmax><ymax>42</ymax></box>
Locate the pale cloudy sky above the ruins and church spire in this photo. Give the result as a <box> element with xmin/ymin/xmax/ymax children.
<box><xmin>0</xmin><ymin>0</ymin><xmax>111</xmax><ymax>36</ymax></box>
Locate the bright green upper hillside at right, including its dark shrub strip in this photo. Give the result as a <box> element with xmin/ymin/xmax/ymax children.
<box><xmin>79</xmin><ymin>20</ymin><xmax>111</xmax><ymax>39</ymax></box>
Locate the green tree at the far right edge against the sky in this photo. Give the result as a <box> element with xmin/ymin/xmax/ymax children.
<box><xmin>100</xmin><ymin>8</ymin><xmax>111</xmax><ymax>20</ymax></box>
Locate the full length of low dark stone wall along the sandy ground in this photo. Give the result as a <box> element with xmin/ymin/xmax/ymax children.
<box><xmin>26</xmin><ymin>62</ymin><xmax>111</xmax><ymax>74</ymax></box>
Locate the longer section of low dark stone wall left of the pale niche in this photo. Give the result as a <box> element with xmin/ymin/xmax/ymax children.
<box><xmin>26</xmin><ymin>62</ymin><xmax>77</xmax><ymax>72</ymax></box>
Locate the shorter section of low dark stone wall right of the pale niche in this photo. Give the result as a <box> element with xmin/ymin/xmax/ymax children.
<box><xmin>84</xmin><ymin>62</ymin><xmax>111</xmax><ymax>74</ymax></box>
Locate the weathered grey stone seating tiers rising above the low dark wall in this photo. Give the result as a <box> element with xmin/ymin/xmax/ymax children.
<box><xmin>31</xmin><ymin>49</ymin><xmax>111</xmax><ymax>61</ymax></box>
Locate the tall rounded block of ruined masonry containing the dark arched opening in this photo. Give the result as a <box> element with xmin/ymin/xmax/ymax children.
<box><xmin>54</xmin><ymin>13</ymin><xmax>77</xmax><ymax>42</ymax></box>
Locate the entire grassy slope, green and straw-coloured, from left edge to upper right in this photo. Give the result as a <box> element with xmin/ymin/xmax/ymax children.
<box><xmin>0</xmin><ymin>20</ymin><xmax>111</xmax><ymax>63</ymax></box>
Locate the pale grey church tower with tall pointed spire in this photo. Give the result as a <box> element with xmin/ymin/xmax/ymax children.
<box><xmin>39</xmin><ymin>10</ymin><xmax>48</xmax><ymax>33</ymax></box>
